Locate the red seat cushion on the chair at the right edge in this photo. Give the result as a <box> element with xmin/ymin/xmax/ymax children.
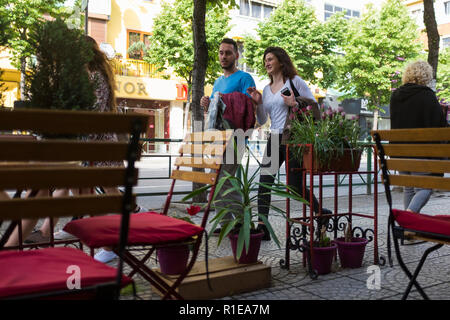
<box><xmin>392</xmin><ymin>209</ymin><xmax>450</xmax><ymax>236</ymax></box>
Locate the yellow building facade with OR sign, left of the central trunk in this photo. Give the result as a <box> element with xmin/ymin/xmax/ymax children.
<box><xmin>89</xmin><ymin>0</ymin><xmax>187</xmax><ymax>151</ymax></box>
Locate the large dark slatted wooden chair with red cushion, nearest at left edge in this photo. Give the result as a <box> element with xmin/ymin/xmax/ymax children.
<box><xmin>0</xmin><ymin>109</ymin><xmax>147</xmax><ymax>299</ymax></box>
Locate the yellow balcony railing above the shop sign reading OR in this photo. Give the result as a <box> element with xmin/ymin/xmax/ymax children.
<box><xmin>112</xmin><ymin>59</ymin><xmax>170</xmax><ymax>79</ymax></box>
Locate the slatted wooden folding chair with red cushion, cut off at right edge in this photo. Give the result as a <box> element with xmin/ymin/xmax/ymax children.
<box><xmin>372</xmin><ymin>128</ymin><xmax>450</xmax><ymax>299</ymax></box>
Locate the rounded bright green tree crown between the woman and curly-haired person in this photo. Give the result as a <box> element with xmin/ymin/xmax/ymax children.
<box><xmin>338</xmin><ymin>0</ymin><xmax>421</xmax><ymax>110</ymax></box>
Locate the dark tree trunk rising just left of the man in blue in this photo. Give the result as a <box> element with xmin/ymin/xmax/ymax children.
<box><xmin>191</xmin><ymin>0</ymin><xmax>208</xmax><ymax>202</ymax></box>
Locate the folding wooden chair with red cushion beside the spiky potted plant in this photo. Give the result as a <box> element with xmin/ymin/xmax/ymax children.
<box><xmin>64</xmin><ymin>131</ymin><xmax>233</xmax><ymax>299</ymax></box>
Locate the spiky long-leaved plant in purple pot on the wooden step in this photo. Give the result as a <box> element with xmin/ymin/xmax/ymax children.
<box><xmin>183</xmin><ymin>158</ymin><xmax>308</xmax><ymax>263</ymax></box>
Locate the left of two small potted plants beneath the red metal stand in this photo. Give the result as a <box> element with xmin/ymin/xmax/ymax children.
<box><xmin>311</xmin><ymin>226</ymin><xmax>337</xmax><ymax>275</ymax></box>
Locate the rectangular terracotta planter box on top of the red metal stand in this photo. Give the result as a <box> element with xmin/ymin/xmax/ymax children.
<box><xmin>303</xmin><ymin>149</ymin><xmax>362</xmax><ymax>172</ymax></box>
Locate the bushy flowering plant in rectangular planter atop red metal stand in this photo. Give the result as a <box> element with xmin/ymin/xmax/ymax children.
<box><xmin>289</xmin><ymin>106</ymin><xmax>363</xmax><ymax>171</ymax></box>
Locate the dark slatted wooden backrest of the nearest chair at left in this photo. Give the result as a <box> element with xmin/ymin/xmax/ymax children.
<box><xmin>0</xmin><ymin>110</ymin><xmax>148</xmax><ymax>230</ymax></box>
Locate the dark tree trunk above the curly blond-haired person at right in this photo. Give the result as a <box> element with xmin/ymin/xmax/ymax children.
<box><xmin>423</xmin><ymin>0</ymin><xmax>440</xmax><ymax>89</ymax></box>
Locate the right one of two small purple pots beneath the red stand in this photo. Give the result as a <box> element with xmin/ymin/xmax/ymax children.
<box><xmin>335</xmin><ymin>238</ymin><xmax>368</xmax><ymax>268</ymax></box>
